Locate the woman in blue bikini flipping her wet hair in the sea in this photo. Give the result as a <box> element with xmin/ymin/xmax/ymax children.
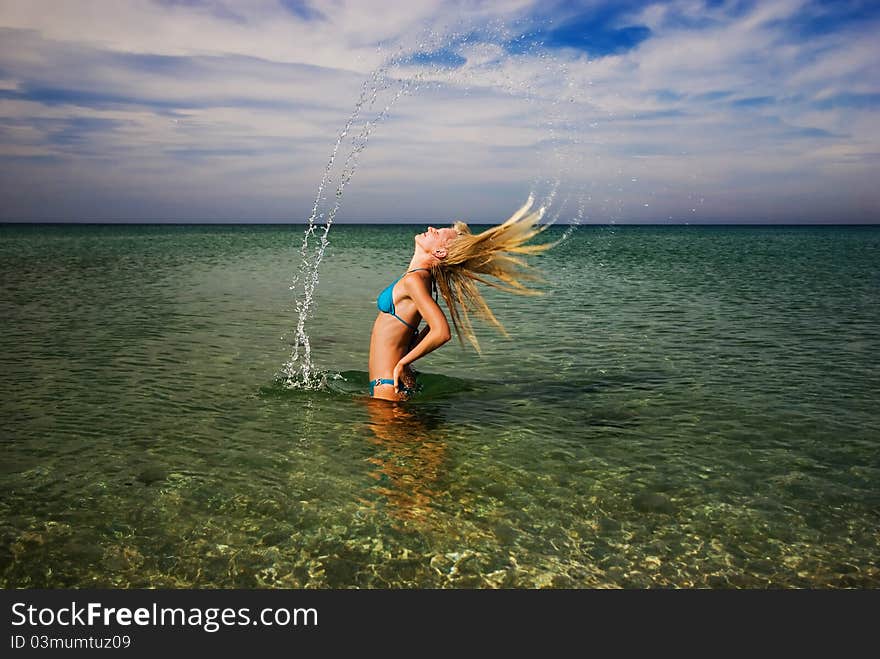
<box><xmin>369</xmin><ymin>197</ymin><xmax>552</xmax><ymax>400</ymax></box>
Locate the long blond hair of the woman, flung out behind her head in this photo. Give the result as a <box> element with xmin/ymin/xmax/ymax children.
<box><xmin>431</xmin><ymin>196</ymin><xmax>556</xmax><ymax>352</ymax></box>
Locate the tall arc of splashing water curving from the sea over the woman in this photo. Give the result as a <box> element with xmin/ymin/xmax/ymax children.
<box><xmin>282</xmin><ymin>24</ymin><xmax>604</xmax><ymax>389</ymax></box>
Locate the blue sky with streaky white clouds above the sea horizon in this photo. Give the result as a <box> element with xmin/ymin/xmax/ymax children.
<box><xmin>0</xmin><ymin>0</ymin><xmax>880</xmax><ymax>224</ymax></box>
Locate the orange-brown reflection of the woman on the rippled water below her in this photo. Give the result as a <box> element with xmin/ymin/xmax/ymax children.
<box><xmin>364</xmin><ymin>398</ymin><xmax>446</xmax><ymax>527</ymax></box>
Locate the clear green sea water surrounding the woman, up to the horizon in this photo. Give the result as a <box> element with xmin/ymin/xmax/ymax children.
<box><xmin>0</xmin><ymin>226</ymin><xmax>880</xmax><ymax>588</ymax></box>
